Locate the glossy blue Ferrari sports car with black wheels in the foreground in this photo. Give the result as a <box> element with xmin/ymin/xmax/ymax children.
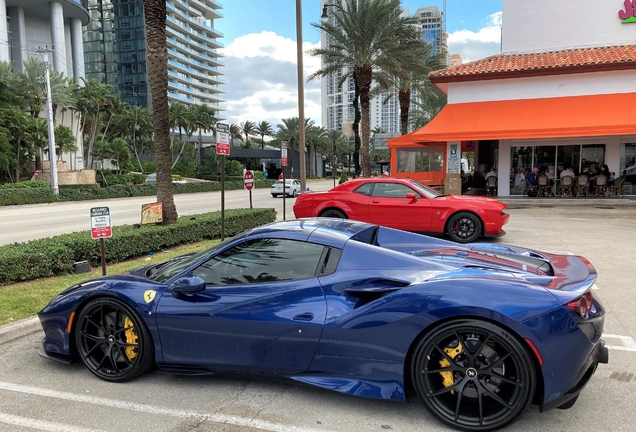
<box><xmin>39</xmin><ymin>218</ymin><xmax>608</xmax><ymax>431</ymax></box>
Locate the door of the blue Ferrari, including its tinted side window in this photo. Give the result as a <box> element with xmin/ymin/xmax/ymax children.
<box><xmin>156</xmin><ymin>238</ymin><xmax>326</xmax><ymax>372</ymax></box>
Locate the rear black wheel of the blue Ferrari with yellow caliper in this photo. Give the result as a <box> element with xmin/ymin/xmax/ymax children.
<box><xmin>410</xmin><ymin>320</ymin><xmax>536</xmax><ymax>431</ymax></box>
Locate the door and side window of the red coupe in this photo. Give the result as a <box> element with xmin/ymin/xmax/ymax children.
<box><xmin>369</xmin><ymin>182</ymin><xmax>432</xmax><ymax>232</ymax></box>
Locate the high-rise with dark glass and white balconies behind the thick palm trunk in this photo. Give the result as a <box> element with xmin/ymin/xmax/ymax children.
<box><xmin>84</xmin><ymin>0</ymin><xmax>223</xmax><ymax>112</ymax></box>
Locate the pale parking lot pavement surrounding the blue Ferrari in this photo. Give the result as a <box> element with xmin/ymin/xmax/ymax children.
<box><xmin>0</xmin><ymin>207</ymin><xmax>636</xmax><ymax>432</ymax></box>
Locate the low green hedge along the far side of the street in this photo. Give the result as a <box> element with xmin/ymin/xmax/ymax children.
<box><xmin>0</xmin><ymin>180</ymin><xmax>274</xmax><ymax>206</ymax></box>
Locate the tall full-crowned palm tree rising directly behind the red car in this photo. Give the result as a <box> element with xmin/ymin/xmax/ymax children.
<box><xmin>310</xmin><ymin>0</ymin><xmax>423</xmax><ymax>176</ymax></box>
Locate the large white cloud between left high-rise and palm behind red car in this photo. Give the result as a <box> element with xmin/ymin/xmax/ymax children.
<box><xmin>222</xmin><ymin>31</ymin><xmax>321</xmax><ymax>128</ymax></box>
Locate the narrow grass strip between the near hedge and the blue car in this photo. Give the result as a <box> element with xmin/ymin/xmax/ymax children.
<box><xmin>0</xmin><ymin>240</ymin><xmax>219</xmax><ymax>325</ymax></box>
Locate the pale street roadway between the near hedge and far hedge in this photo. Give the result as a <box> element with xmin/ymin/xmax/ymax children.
<box><xmin>0</xmin><ymin>180</ymin><xmax>333</xmax><ymax>246</ymax></box>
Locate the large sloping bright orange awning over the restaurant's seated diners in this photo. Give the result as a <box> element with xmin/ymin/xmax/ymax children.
<box><xmin>412</xmin><ymin>93</ymin><xmax>636</xmax><ymax>143</ymax></box>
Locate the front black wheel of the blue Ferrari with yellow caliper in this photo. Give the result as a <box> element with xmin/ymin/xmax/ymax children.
<box><xmin>75</xmin><ymin>297</ymin><xmax>154</xmax><ymax>382</ymax></box>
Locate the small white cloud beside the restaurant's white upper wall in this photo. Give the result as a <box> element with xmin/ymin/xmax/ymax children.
<box><xmin>448</xmin><ymin>12</ymin><xmax>502</xmax><ymax>62</ymax></box>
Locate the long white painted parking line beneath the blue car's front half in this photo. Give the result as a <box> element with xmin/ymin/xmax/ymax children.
<box><xmin>0</xmin><ymin>381</ymin><xmax>336</xmax><ymax>432</ymax></box>
